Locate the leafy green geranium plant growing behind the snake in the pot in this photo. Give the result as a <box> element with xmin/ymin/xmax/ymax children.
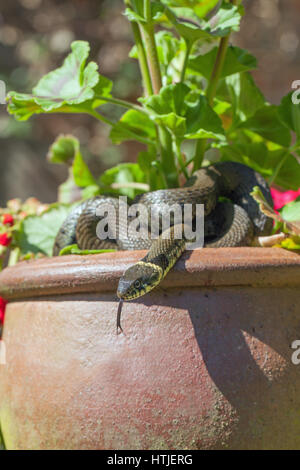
<box><xmin>0</xmin><ymin>0</ymin><xmax>300</xmax><ymax>272</ymax></box>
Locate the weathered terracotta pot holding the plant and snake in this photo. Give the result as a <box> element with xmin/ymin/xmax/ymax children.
<box><xmin>0</xmin><ymin>248</ymin><xmax>300</xmax><ymax>449</ymax></box>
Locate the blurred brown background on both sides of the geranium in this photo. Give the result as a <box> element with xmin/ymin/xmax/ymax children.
<box><xmin>0</xmin><ymin>0</ymin><xmax>300</xmax><ymax>206</ymax></box>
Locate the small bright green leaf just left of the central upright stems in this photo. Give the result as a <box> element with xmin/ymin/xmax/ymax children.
<box><xmin>110</xmin><ymin>110</ymin><xmax>156</xmax><ymax>144</ymax></box>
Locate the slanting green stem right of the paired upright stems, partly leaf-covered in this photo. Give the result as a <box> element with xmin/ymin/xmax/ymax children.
<box><xmin>194</xmin><ymin>0</ymin><xmax>238</xmax><ymax>171</ymax></box>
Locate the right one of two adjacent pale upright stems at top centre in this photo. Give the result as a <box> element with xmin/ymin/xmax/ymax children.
<box><xmin>140</xmin><ymin>0</ymin><xmax>162</xmax><ymax>94</ymax></box>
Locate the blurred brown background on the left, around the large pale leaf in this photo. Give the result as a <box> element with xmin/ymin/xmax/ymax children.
<box><xmin>0</xmin><ymin>0</ymin><xmax>142</xmax><ymax>205</ymax></box>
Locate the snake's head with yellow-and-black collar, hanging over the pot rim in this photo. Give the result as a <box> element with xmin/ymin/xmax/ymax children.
<box><xmin>117</xmin><ymin>261</ymin><xmax>163</xmax><ymax>300</ymax></box>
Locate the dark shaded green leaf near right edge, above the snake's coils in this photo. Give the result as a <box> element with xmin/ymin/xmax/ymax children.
<box><xmin>239</xmin><ymin>105</ymin><xmax>291</xmax><ymax>147</ymax></box>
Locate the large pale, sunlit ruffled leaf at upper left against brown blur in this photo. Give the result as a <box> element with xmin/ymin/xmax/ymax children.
<box><xmin>8</xmin><ymin>41</ymin><xmax>112</xmax><ymax>120</ymax></box>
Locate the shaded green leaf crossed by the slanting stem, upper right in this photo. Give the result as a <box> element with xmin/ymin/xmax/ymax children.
<box><xmin>188</xmin><ymin>46</ymin><xmax>257</xmax><ymax>80</ymax></box>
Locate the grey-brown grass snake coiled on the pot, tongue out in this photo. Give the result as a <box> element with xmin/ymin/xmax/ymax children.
<box><xmin>53</xmin><ymin>161</ymin><xmax>273</xmax><ymax>328</ymax></box>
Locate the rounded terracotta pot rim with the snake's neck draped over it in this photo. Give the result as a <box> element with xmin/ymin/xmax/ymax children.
<box><xmin>0</xmin><ymin>247</ymin><xmax>300</xmax><ymax>300</ymax></box>
